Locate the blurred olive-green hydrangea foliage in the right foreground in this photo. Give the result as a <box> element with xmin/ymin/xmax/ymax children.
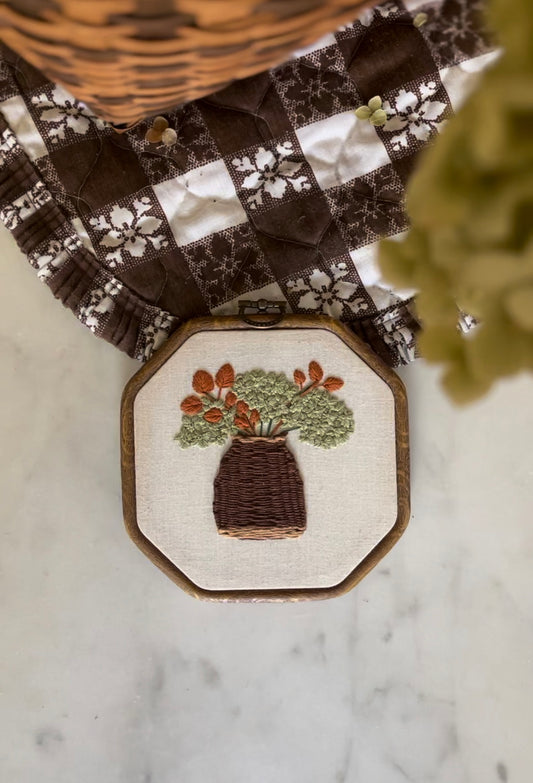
<box><xmin>380</xmin><ymin>0</ymin><xmax>533</xmax><ymax>403</ymax></box>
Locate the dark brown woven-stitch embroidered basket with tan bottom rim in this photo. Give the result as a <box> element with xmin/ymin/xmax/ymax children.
<box><xmin>213</xmin><ymin>436</ymin><xmax>306</xmax><ymax>539</ymax></box>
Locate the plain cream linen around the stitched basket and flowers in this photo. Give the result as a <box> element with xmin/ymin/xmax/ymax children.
<box><xmin>134</xmin><ymin>329</ymin><xmax>397</xmax><ymax>590</ymax></box>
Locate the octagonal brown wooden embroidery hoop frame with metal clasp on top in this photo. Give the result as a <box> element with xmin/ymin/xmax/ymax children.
<box><xmin>121</xmin><ymin>300</ymin><xmax>410</xmax><ymax>601</ymax></box>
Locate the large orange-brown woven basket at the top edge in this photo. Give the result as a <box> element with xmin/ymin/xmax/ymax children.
<box><xmin>0</xmin><ymin>0</ymin><xmax>371</xmax><ymax>124</ymax></box>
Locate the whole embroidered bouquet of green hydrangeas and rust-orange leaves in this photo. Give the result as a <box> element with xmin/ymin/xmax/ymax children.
<box><xmin>175</xmin><ymin>361</ymin><xmax>354</xmax><ymax>449</ymax></box>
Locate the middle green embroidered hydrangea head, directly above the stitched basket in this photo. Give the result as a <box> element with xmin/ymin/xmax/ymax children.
<box><xmin>233</xmin><ymin>370</ymin><xmax>299</xmax><ymax>422</ymax></box>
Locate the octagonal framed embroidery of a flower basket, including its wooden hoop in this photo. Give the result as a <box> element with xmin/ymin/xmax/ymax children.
<box><xmin>122</xmin><ymin>314</ymin><xmax>409</xmax><ymax>600</ymax></box>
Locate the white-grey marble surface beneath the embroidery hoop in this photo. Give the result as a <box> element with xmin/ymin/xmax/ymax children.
<box><xmin>0</xmin><ymin>224</ymin><xmax>533</xmax><ymax>783</ymax></box>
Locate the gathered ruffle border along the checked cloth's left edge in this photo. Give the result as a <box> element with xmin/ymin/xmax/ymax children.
<box><xmin>0</xmin><ymin>116</ymin><xmax>179</xmax><ymax>361</ymax></box>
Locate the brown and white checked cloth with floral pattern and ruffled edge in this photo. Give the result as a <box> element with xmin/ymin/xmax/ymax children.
<box><xmin>0</xmin><ymin>0</ymin><xmax>491</xmax><ymax>365</ymax></box>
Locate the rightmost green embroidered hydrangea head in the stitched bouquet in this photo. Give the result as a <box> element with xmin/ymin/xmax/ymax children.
<box><xmin>284</xmin><ymin>389</ymin><xmax>354</xmax><ymax>449</ymax></box>
